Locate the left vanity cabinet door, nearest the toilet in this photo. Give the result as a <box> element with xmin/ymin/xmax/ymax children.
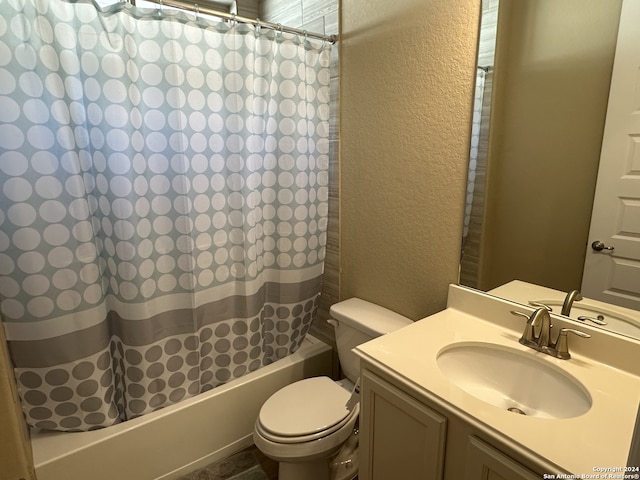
<box><xmin>359</xmin><ymin>371</ymin><xmax>447</xmax><ymax>480</ymax></box>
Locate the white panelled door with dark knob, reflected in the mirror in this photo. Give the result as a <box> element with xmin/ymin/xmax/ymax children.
<box><xmin>582</xmin><ymin>0</ymin><xmax>640</xmax><ymax>310</ymax></box>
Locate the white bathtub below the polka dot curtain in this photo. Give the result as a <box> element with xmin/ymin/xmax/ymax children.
<box><xmin>31</xmin><ymin>335</ymin><xmax>333</xmax><ymax>480</ymax></box>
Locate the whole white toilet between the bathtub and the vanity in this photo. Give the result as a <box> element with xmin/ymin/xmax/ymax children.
<box><xmin>253</xmin><ymin>298</ymin><xmax>413</xmax><ymax>480</ymax></box>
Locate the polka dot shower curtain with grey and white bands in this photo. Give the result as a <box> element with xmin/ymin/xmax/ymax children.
<box><xmin>0</xmin><ymin>0</ymin><xmax>330</xmax><ymax>431</ymax></box>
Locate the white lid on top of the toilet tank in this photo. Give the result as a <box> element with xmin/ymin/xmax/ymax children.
<box><xmin>329</xmin><ymin>298</ymin><xmax>413</xmax><ymax>336</ymax></box>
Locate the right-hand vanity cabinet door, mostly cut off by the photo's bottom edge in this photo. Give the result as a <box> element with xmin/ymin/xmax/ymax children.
<box><xmin>465</xmin><ymin>437</ymin><xmax>540</xmax><ymax>480</ymax></box>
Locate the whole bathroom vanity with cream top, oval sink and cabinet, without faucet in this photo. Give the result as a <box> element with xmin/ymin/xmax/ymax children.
<box><xmin>355</xmin><ymin>286</ymin><xmax>640</xmax><ymax>480</ymax></box>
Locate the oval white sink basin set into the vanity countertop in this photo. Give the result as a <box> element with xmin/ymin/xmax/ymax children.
<box><xmin>437</xmin><ymin>342</ymin><xmax>591</xmax><ymax>418</ymax></box>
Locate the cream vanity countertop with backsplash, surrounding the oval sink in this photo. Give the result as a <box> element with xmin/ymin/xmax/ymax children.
<box><xmin>355</xmin><ymin>286</ymin><xmax>640</xmax><ymax>475</ymax></box>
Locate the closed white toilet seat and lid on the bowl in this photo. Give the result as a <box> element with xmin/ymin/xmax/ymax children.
<box><xmin>256</xmin><ymin>376</ymin><xmax>359</xmax><ymax>443</ymax></box>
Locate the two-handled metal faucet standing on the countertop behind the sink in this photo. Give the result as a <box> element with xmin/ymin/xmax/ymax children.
<box><xmin>511</xmin><ymin>307</ymin><xmax>591</xmax><ymax>360</ymax></box>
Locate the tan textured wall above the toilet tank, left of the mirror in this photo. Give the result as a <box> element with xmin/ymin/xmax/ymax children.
<box><xmin>340</xmin><ymin>0</ymin><xmax>480</xmax><ymax>319</ymax></box>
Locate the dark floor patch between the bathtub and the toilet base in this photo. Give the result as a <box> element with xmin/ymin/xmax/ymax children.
<box><xmin>179</xmin><ymin>447</ymin><xmax>278</xmax><ymax>480</ymax></box>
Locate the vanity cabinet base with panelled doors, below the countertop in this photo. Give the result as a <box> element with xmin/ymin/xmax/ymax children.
<box><xmin>359</xmin><ymin>363</ymin><xmax>549</xmax><ymax>480</ymax></box>
